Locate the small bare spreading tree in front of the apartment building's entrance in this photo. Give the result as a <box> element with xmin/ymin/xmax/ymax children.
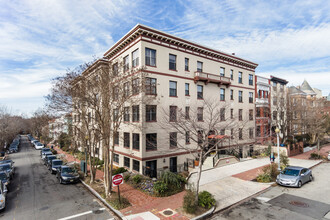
<box><xmin>161</xmin><ymin>99</ymin><xmax>250</xmax><ymax>205</ymax></box>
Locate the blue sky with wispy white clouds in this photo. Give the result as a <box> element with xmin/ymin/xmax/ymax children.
<box><xmin>0</xmin><ymin>0</ymin><xmax>330</xmax><ymax>116</ymax></box>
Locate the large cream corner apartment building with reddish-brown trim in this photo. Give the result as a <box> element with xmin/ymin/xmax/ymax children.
<box><xmin>73</xmin><ymin>24</ymin><xmax>257</xmax><ymax>177</ymax></box>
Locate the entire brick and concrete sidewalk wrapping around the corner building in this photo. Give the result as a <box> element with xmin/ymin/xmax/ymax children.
<box><xmin>56</xmin><ymin>146</ymin><xmax>322</xmax><ymax>220</ymax></box>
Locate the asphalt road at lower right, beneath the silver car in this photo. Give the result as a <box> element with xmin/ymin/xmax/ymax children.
<box><xmin>211</xmin><ymin>163</ymin><xmax>330</xmax><ymax>220</ymax></box>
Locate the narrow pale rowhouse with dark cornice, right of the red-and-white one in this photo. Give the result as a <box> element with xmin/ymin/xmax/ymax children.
<box><xmin>270</xmin><ymin>76</ymin><xmax>288</xmax><ymax>138</ymax></box>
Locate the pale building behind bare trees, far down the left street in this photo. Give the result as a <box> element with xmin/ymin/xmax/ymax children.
<box><xmin>48</xmin><ymin>114</ymin><xmax>72</xmax><ymax>140</ymax></box>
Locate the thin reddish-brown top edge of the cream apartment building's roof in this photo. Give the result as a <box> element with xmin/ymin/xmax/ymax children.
<box><xmin>103</xmin><ymin>24</ymin><xmax>258</xmax><ymax>69</ymax></box>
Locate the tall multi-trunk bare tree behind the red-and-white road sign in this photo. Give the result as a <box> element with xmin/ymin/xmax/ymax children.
<box><xmin>73</xmin><ymin>59</ymin><xmax>148</xmax><ymax>197</ymax></box>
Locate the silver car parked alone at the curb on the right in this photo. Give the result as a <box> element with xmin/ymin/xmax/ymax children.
<box><xmin>276</xmin><ymin>166</ymin><xmax>313</xmax><ymax>188</ymax></box>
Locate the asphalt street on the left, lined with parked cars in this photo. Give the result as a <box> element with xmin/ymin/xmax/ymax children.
<box><xmin>0</xmin><ymin>136</ymin><xmax>113</xmax><ymax>220</ymax></box>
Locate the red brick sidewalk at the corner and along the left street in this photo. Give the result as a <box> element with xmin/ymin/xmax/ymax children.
<box><xmin>55</xmin><ymin>147</ymin><xmax>189</xmax><ymax>220</ymax></box>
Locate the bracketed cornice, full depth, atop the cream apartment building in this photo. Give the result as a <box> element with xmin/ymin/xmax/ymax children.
<box><xmin>104</xmin><ymin>24</ymin><xmax>258</xmax><ymax>71</ymax></box>
